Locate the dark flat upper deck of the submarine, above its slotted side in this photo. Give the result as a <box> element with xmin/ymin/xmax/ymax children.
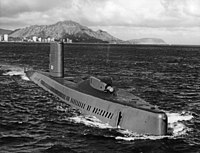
<box><xmin>39</xmin><ymin>72</ymin><xmax>162</xmax><ymax>113</ymax></box>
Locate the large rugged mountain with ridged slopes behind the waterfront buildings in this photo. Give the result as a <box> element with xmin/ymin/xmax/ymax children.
<box><xmin>9</xmin><ymin>21</ymin><xmax>121</xmax><ymax>43</ymax></box>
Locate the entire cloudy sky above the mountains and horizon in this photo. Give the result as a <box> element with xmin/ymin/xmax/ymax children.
<box><xmin>0</xmin><ymin>0</ymin><xmax>200</xmax><ymax>45</ymax></box>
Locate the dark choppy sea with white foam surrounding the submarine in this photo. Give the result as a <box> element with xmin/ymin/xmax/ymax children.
<box><xmin>0</xmin><ymin>43</ymin><xmax>200</xmax><ymax>153</ymax></box>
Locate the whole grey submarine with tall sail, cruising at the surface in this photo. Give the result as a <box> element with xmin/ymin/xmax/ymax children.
<box><xmin>25</xmin><ymin>42</ymin><xmax>168</xmax><ymax>136</ymax></box>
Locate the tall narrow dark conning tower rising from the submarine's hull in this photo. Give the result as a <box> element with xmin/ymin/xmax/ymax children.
<box><xmin>49</xmin><ymin>42</ymin><xmax>64</xmax><ymax>78</ymax></box>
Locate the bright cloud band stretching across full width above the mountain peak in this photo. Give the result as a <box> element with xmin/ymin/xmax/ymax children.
<box><xmin>0</xmin><ymin>0</ymin><xmax>200</xmax><ymax>28</ymax></box>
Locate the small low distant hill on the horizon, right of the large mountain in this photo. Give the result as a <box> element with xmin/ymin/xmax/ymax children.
<box><xmin>126</xmin><ymin>38</ymin><xmax>166</xmax><ymax>44</ymax></box>
